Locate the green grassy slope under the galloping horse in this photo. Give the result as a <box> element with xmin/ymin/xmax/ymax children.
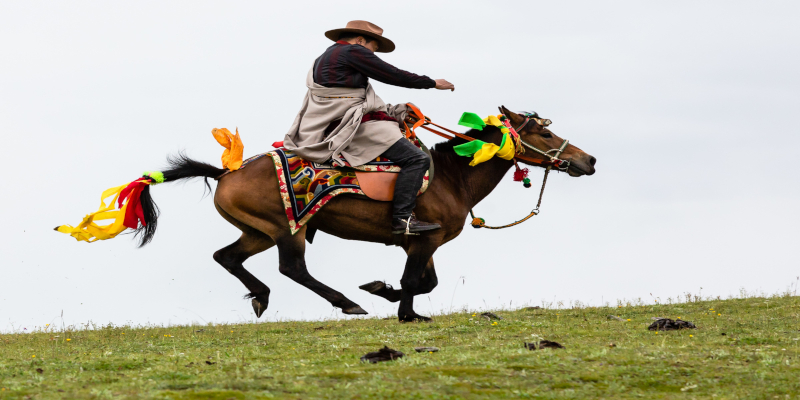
<box><xmin>0</xmin><ymin>296</ymin><xmax>800</xmax><ymax>400</ymax></box>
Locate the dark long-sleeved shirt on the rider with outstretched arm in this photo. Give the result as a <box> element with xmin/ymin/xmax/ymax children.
<box><xmin>314</xmin><ymin>41</ymin><xmax>436</xmax><ymax>89</ymax></box>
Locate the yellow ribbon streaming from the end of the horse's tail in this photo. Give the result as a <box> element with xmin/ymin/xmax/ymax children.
<box><xmin>56</xmin><ymin>183</ymin><xmax>128</xmax><ymax>243</ymax></box>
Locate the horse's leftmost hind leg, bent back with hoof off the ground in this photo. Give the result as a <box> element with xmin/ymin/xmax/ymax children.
<box><xmin>214</xmin><ymin>230</ymin><xmax>275</xmax><ymax>317</ymax></box>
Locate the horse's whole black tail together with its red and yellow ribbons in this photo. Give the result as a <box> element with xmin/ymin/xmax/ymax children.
<box><xmin>55</xmin><ymin>153</ymin><xmax>227</xmax><ymax>247</ymax></box>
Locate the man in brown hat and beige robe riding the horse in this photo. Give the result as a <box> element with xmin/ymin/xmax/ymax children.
<box><xmin>283</xmin><ymin>21</ymin><xmax>455</xmax><ymax>234</ymax></box>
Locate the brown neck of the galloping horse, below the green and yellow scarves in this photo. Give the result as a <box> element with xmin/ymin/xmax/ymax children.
<box><xmin>434</xmin><ymin>131</ymin><xmax>514</xmax><ymax>208</ymax></box>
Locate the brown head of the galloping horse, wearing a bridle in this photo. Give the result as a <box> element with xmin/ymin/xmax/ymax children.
<box><xmin>500</xmin><ymin>106</ymin><xmax>597</xmax><ymax>176</ymax></box>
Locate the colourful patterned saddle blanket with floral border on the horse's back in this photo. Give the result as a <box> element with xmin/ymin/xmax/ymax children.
<box><xmin>234</xmin><ymin>149</ymin><xmax>430</xmax><ymax>234</ymax></box>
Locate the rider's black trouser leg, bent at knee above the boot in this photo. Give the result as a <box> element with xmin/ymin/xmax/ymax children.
<box><xmin>381</xmin><ymin>139</ymin><xmax>431</xmax><ymax>219</ymax></box>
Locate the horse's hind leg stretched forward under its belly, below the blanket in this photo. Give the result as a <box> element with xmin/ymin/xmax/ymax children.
<box><xmin>275</xmin><ymin>227</ymin><xmax>367</xmax><ymax>314</ymax></box>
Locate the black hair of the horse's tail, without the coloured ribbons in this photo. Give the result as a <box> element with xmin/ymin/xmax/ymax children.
<box><xmin>133</xmin><ymin>153</ymin><xmax>227</xmax><ymax>247</ymax></box>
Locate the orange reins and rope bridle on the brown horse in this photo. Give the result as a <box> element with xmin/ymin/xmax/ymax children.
<box><xmin>403</xmin><ymin>103</ymin><xmax>570</xmax><ymax>229</ymax></box>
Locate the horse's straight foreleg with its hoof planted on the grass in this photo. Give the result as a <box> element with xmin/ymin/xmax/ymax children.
<box><xmin>397</xmin><ymin>239</ymin><xmax>440</xmax><ymax>322</ymax></box>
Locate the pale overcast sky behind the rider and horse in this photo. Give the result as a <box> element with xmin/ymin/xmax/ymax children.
<box><xmin>0</xmin><ymin>1</ymin><xmax>800</xmax><ymax>331</ymax></box>
